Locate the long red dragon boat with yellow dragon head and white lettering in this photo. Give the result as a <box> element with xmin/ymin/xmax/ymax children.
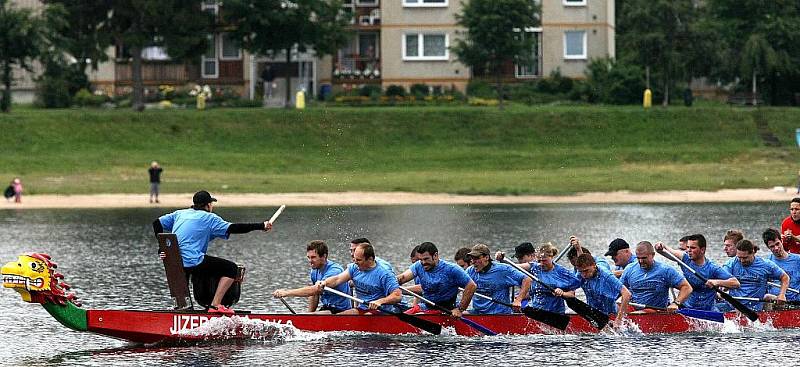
<box><xmin>2</xmin><ymin>253</ymin><xmax>800</xmax><ymax>344</ymax></box>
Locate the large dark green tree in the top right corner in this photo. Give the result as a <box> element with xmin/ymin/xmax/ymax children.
<box><xmin>707</xmin><ymin>0</ymin><xmax>800</xmax><ymax>104</ymax></box>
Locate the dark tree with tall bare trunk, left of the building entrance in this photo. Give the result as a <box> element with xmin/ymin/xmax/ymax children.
<box><xmin>99</xmin><ymin>0</ymin><xmax>213</xmax><ymax>111</ymax></box>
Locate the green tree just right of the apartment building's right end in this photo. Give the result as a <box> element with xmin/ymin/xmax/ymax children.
<box><xmin>617</xmin><ymin>0</ymin><xmax>708</xmax><ymax>106</ymax></box>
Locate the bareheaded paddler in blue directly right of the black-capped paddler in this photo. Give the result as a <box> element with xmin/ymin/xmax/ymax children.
<box><xmin>619</xmin><ymin>241</ymin><xmax>692</xmax><ymax>311</ymax></box>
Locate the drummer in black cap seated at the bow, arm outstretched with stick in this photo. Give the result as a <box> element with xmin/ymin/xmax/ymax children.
<box><xmin>153</xmin><ymin>190</ymin><xmax>272</xmax><ymax>314</ymax></box>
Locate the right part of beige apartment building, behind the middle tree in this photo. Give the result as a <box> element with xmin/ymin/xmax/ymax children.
<box><xmin>318</xmin><ymin>0</ymin><xmax>615</xmax><ymax>90</ymax></box>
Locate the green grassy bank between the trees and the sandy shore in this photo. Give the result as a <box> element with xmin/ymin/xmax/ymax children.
<box><xmin>0</xmin><ymin>106</ymin><xmax>800</xmax><ymax>194</ymax></box>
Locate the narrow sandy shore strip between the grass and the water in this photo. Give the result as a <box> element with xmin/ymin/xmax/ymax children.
<box><xmin>0</xmin><ymin>187</ymin><xmax>797</xmax><ymax>209</ymax></box>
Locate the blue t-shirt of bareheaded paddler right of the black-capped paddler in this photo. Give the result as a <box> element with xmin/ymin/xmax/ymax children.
<box><xmin>619</xmin><ymin>261</ymin><xmax>685</xmax><ymax>307</ymax></box>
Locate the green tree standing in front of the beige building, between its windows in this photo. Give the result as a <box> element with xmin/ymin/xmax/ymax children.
<box><xmin>451</xmin><ymin>0</ymin><xmax>540</xmax><ymax>108</ymax></box>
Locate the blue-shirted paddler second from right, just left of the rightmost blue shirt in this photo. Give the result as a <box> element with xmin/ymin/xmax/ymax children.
<box><xmin>721</xmin><ymin>239</ymin><xmax>789</xmax><ymax>311</ymax></box>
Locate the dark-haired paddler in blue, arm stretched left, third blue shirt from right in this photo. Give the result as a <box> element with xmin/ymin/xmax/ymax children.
<box><xmin>655</xmin><ymin>234</ymin><xmax>740</xmax><ymax>311</ymax></box>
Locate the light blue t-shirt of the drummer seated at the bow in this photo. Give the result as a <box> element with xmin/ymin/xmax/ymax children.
<box><xmin>158</xmin><ymin>208</ymin><xmax>231</xmax><ymax>268</ymax></box>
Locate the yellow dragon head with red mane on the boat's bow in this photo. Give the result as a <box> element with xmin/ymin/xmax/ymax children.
<box><xmin>0</xmin><ymin>253</ymin><xmax>77</xmax><ymax>305</ymax></box>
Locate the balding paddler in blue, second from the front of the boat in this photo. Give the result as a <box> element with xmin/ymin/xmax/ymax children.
<box><xmin>317</xmin><ymin>243</ymin><xmax>403</xmax><ymax>315</ymax></box>
